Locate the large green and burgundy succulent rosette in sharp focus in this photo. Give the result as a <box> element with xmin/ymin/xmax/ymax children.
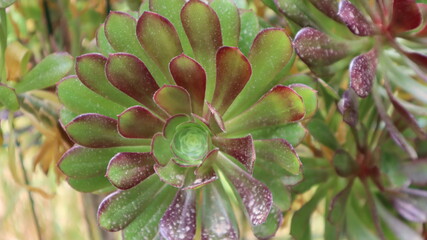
<box><xmin>57</xmin><ymin>0</ymin><xmax>317</xmax><ymax>239</ymax></box>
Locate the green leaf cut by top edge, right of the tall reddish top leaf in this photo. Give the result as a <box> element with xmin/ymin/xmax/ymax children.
<box><xmin>210</xmin><ymin>0</ymin><xmax>240</xmax><ymax>47</ymax></box>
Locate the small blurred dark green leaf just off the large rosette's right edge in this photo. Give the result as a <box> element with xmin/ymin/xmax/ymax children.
<box><xmin>307</xmin><ymin>118</ymin><xmax>339</xmax><ymax>150</ymax></box>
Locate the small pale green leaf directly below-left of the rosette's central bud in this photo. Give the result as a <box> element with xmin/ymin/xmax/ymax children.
<box><xmin>154</xmin><ymin>160</ymin><xmax>188</xmax><ymax>188</ymax></box>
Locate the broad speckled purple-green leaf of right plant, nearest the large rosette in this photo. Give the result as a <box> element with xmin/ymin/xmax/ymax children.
<box><xmin>293</xmin><ymin>27</ymin><xmax>348</xmax><ymax>66</ymax></box>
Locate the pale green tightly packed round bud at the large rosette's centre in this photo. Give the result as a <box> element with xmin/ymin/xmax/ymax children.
<box><xmin>172</xmin><ymin>123</ymin><xmax>209</xmax><ymax>165</ymax></box>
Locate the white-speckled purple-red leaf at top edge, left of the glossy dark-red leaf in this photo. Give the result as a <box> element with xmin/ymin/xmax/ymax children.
<box><xmin>338</xmin><ymin>0</ymin><xmax>374</xmax><ymax>36</ymax></box>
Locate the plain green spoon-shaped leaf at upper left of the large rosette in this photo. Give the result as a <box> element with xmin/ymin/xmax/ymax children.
<box><xmin>104</xmin><ymin>12</ymin><xmax>169</xmax><ymax>86</ymax></box>
